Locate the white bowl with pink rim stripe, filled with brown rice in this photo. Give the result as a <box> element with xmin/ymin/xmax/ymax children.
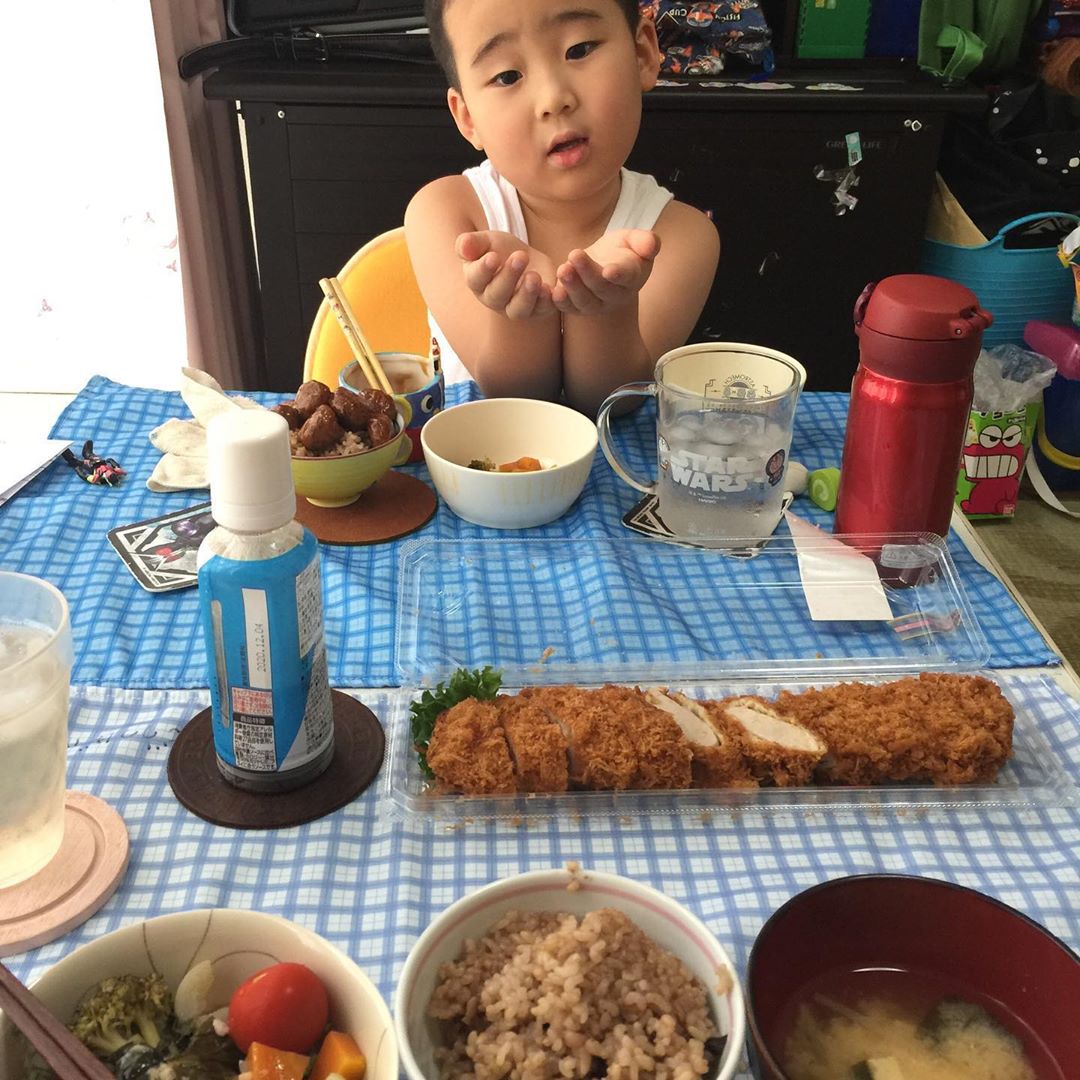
<box><xmin>394</xmin><ymin>863</ymin><xmax>745</xmax><ymax>1080</ymax></box>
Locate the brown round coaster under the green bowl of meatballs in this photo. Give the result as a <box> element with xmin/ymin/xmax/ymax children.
<box><xmin>296</xmin><ymin>472</ymin><xmax>438</xmax><ymax>544</ymax></box>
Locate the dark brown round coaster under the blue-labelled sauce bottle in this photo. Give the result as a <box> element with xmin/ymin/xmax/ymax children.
<box><xmin>168</xmin><ymin>690</ymin><xmax>386</xmax><ymax>828</ymax></box>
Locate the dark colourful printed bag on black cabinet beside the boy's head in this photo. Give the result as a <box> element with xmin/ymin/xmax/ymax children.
<box><xmin>640</xmin><ymin>0</ymin><xmax>774</xmax><ymax>75</ymax></box>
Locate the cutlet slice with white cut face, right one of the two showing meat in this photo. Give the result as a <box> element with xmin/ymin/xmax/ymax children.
<box><xmin>703</xmin><ymin>696</ymin><xmax>828</xmax><ymax>787</ymax></box>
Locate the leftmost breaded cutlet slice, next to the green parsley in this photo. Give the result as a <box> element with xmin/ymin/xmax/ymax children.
<box><xmin>428</xmin><ymin>698</ymin><xmax>517</xmax><ymax>795</ymax></box>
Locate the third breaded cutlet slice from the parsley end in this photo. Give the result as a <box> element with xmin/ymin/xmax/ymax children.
<box><xmin>517</xmin><ymin>686</ymin><xmax>637</xmax><ymax>791</ymax></box>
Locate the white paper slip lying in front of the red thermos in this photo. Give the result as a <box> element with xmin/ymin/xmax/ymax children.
<box><xmin>784</xmin><ymin>510</ymin><xmax>892</xmax><ymax>622</ymax></box>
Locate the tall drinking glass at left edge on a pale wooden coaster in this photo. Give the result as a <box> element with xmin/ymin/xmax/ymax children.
<box><xmin>0</xmin><ymin>571</ymin><xmax>72</xmax><ymax>889</ymax></box>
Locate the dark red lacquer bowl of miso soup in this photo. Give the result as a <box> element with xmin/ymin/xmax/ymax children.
<box><xmin>746</xmin><ymin>874</ymin><xmax>1080</xmax><ymax>1080</ymax></box>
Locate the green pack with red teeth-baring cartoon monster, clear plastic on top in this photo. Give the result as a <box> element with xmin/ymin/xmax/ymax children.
<box><xmin>956</xmin><ymin>345</ymin><xmax>1054</xmax><ymax>517</ymax></box>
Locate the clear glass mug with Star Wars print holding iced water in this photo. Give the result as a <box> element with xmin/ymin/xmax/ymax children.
<box><xmin>596</xmin><ymin>341</ymin><xmax>806</xmax><ymax>548</ymax></box>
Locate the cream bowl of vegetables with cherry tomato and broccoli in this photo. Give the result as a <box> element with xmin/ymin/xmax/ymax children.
<box><xmin>0</xmin><ymin>909</ymin><xmax>397</xmax><ymax>1080</ymax></box>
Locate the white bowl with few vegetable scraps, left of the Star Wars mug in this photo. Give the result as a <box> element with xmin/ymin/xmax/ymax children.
<box><xmin>420</xmin><ymin>397</ymin><xmax>596</xmax><ymax>529</ymax></box>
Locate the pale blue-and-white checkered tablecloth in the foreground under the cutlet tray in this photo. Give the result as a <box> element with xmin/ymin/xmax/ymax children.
<box><xmin>5</xmin><ymin>674</ymin><xmax>1080</xmax><ymax>1080</ymax></box>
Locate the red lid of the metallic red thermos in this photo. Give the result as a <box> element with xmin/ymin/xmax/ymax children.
<box><xmin>855</xmin><ymin>273</ymin><xmax>994</xmax><ymax>382</ymax></box>
